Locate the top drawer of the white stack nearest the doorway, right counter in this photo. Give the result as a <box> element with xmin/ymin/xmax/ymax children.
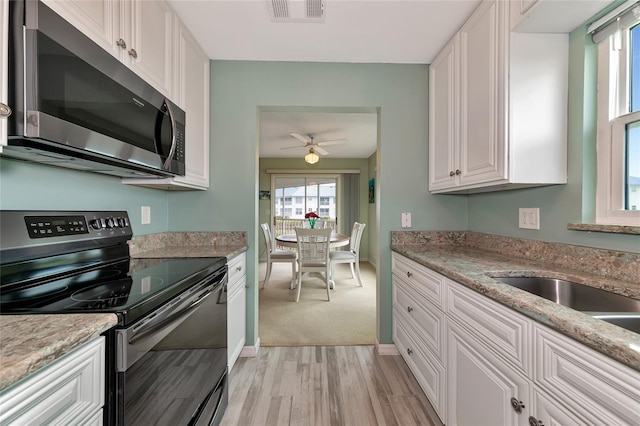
<box><xmin>392</xmin><ymin>253</ymin><xmax>445</xmax><ymax>309</ymax></box>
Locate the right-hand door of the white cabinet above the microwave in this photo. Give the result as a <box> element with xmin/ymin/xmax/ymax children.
<box><xmin>123</xmin><ymin>0</ymin><xmax>174</xmax><ymax>98</ymax></box>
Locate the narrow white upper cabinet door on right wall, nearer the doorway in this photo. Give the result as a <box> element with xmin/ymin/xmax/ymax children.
<box><xmin>429</xmin><ymin>35</ymin><xmax>460</xmax><ymax>191</ymax></box>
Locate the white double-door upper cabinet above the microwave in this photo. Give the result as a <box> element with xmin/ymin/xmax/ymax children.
<box><xmin>44</xmin><ymin>0</ymin><xmax>174</xmax><ymax>98</ymax></box>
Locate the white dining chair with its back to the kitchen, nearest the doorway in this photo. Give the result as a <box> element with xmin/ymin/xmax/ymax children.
<box><xmin>296</xmin><ymin>228</ymin><xmax>331</xmax><ymax>302</ymax></box>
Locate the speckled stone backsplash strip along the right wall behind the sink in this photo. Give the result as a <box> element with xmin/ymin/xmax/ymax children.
<box><xmin>391</xmin><ymin>231</ymin><xmax>640</xmax><ymax>283</ymax></box>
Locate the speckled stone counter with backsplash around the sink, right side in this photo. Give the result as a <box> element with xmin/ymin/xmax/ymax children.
<box><xmin>391</xmin><ymin>231</ymin><xmax>640</xmax><ymax>371</ymax></box>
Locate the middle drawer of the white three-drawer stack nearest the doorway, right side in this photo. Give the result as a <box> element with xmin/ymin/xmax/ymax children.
<box><xmin>393</xmin><ymin>277</ymin><xmax>446</xmax><ymax>362</ymax></box>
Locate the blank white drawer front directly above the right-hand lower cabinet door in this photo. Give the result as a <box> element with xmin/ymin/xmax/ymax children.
<box><xmin>447</xmin><ymin>280</ymin><xmax>532</xmax><ymax>377</ymax></box>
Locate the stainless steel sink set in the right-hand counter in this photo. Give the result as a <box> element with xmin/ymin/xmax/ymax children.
<box><xmin>493</xmin><ymin>277</ymin><xmax>640</xmax><ymax>333</ymax></box>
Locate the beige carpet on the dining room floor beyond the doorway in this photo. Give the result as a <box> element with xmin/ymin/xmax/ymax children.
<box><xmin>258</xmin><ymin>262</ymin><xmax>376</xmax><ymax>346</ymax></box>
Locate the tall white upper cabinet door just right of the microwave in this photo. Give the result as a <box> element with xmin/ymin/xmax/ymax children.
<box><xmin>176</xmin><ymin>26</ymin><xmax>209</xmax><ymax>189</ymax></box>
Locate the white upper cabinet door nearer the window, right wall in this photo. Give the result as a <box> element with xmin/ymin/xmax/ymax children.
<box><xmin>458</xmin><ymin>1</ymin><xmax>508</xmax><ymax>185</ymax></box>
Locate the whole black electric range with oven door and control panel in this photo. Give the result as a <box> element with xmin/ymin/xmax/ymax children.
<box><xmin>0</xmin><ymin>210</ymin><xmax>228</xmax><ymax>426</ymax></box>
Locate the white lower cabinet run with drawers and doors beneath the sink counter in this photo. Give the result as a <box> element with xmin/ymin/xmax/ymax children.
<box><xmin>392</xmin><ymin>253</ymin><xmax>640</xmax><ymax>426</ymax></box>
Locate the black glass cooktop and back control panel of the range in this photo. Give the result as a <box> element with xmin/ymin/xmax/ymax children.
<box><xmin>0</xmin><ymin>211</ymin><xmax>226</xmax><ymax>325</ymax></box>
